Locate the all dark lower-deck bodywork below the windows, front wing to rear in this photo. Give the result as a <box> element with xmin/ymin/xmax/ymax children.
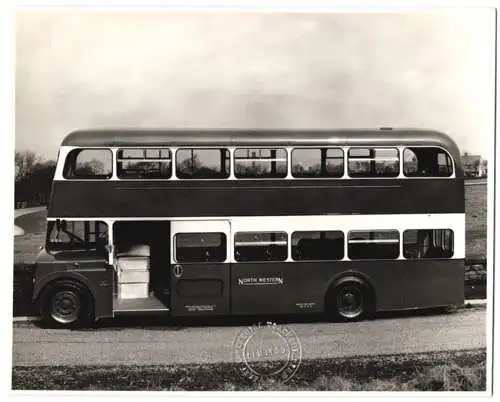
<box><xmin>33</xmin><ymin>252</ymin><xmax>464</xmax><ymax>319</ymax></box>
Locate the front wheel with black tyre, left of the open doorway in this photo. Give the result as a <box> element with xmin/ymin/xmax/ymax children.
<box><xmin>41</xmin><ymin>280</ymin><xmax>94</xmax><ymax>328</ymax></box>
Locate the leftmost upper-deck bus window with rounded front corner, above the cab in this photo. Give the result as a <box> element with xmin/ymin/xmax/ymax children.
<box><xmin>64</xmin><ymin>148</ymin><xmax>113</xmax><ymax>179</ymax></box>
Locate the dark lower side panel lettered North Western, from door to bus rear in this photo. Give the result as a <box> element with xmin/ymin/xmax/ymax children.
<box><xmin>231</xmin><ymin>259</ymin><xmax>464</xmax><ymax>315</ymax></box>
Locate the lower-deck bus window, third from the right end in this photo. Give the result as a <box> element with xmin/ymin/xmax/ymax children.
<box><xmin>292</xmin><ymin>231</ymin><xmax>344</xmax><ymax>261</ymax></box>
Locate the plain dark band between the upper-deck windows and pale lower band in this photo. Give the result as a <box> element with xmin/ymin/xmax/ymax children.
<box><xmin>48</xmin><ymin>178</ymin><xmax>465</xmax><ymax>218</ymax></box>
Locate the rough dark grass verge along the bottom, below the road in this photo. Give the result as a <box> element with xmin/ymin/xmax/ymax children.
<box><xmin>12</xmin><ymin>349</ymin><xmax>486</xmax><ymax>391</ymax></box>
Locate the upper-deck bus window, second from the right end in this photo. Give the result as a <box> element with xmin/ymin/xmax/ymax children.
<box><xmin>348</xmin><ymin>148</ymin><xmax>399</xmax><ymax>177</ymax></box>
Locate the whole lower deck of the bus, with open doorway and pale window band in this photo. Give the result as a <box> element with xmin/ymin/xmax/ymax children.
<box><xmin>35</xmin><ymin>214</ymin><xmax>465</xmax><ymax>325</ymax></box>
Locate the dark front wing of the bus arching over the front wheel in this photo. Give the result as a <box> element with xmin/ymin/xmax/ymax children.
<box><xmin>33</xmin><ymin>250</ymin><xmax>114</xmax><ymax>319</ymax></box>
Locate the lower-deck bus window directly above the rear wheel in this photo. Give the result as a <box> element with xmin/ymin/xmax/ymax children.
<box><xmin>347</xmin><ymin>230</ymin><xmax>399</xmax><ymax>260</ymax></box>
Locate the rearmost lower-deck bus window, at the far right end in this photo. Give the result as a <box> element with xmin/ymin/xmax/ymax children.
<box><xmin>403</xmin><ymin>229</ymin><xmax>453</xmax><ymax>259</ymax></box>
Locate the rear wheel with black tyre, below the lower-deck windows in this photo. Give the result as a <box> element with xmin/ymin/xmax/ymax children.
<box><xmin>327</xmin><ymin>281</ymin><xmax>373</xmax><ymax>321</ymax></box>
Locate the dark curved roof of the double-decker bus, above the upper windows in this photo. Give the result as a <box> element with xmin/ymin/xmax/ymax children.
<box><xmin>62</xmin><ymin>128</ymin><xmax>460</xmax><ymax>160</ymax></box>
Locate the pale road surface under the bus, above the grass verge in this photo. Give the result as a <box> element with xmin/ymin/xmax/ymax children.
<box><xmin>13</xmin><ymin>308</ymin><xmax>486</xmax><ymax>366</ymax></box>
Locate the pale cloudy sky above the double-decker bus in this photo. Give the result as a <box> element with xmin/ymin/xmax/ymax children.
<box><xmin>15</xmin><ymin>9</ymin><xmax>495</xmax><ymax>159</ymax></box>
